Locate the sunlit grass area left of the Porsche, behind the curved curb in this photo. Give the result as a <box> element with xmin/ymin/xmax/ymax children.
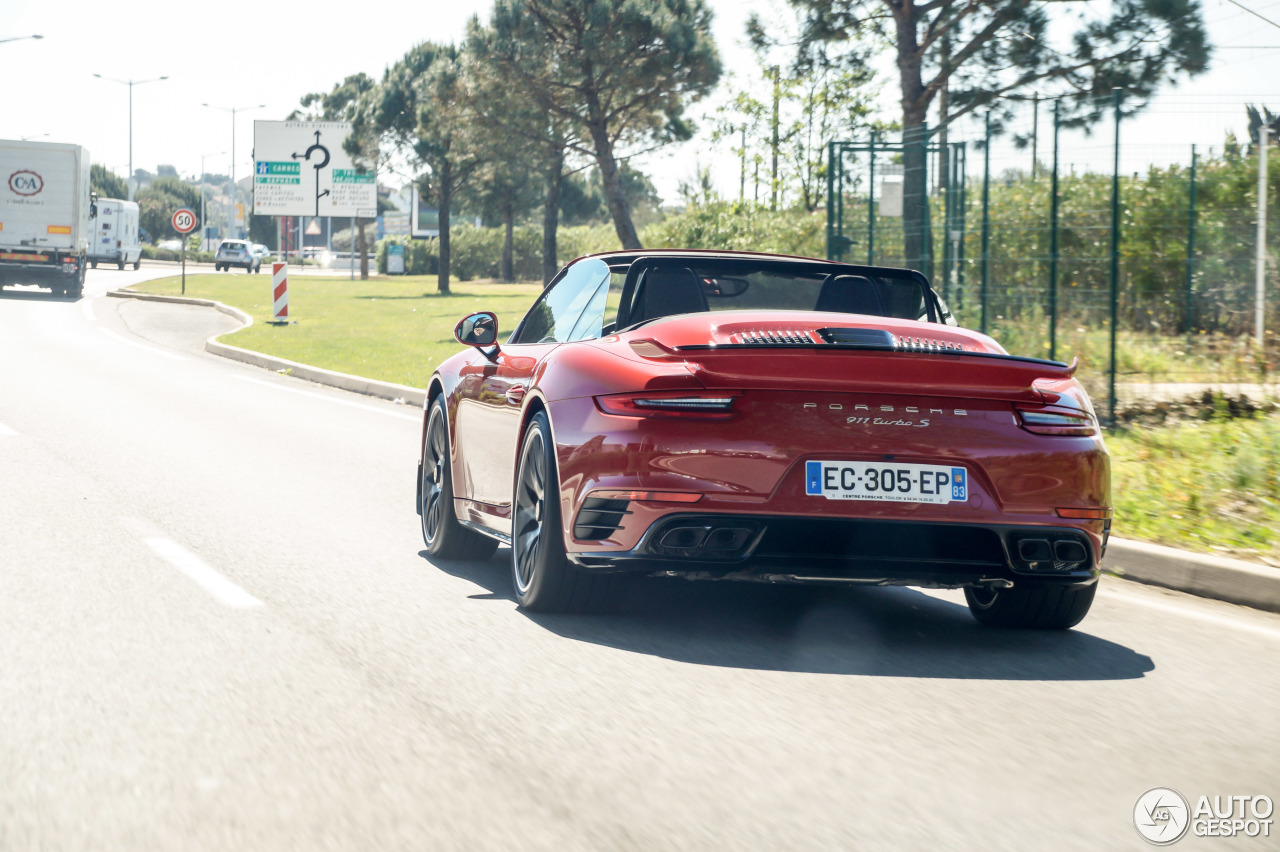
<box><xmin>132</xmin><ymin>272</ymin><xmax>541</xmax><ymax>388</ymax></box>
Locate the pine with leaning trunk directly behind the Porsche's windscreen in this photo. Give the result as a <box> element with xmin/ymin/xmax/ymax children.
<box><xmin>486</xmin><ymin>0</ymin><xmax>721</xmax><ymax>248</ymax></box>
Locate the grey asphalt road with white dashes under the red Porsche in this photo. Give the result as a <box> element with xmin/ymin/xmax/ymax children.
<box><xmin>0</xmin><ymin>267</ymin><xmax>1280</xmax><ymax>851</ymax></box>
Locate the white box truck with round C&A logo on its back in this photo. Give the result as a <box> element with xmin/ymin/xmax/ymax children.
<box><xmin>0</xmin><ymin>139</ymin><xmax>95</xmax><ymax>296</ymax></box>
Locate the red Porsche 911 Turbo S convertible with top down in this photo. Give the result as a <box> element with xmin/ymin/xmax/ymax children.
<box><xmin>417</xmin><ymin>251</ymin><xmax>1111</xmax><ymax>628</ymax></box>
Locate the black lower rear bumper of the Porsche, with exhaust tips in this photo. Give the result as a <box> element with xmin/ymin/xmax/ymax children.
<box><xmin>568</xmin><ymin>513</ymin><xmax>1100</xmax><ymax>588</ymax></box>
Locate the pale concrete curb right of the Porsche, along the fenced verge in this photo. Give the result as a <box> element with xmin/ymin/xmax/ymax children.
<box><xmin>1102</xmin><ymin>537</ymin><xmax>1280</xmax><ymax>613</ymax></box>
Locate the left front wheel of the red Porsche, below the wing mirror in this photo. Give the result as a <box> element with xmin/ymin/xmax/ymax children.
<box><xmin>417</xmin><ymin>395</ymin><xmax>498</xmax><ymax>560</ymax></box>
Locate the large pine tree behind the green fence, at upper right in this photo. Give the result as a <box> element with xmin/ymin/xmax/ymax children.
<box><xmin>788</xmin><ymin>0</ymin><xmax>1210</xmax><ymax>267</ymax></box>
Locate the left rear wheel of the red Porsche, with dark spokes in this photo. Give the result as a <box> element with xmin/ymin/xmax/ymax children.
<box><xmin>511</xmin><ymin>411</ymin><xmax>621</xmax><ymax>613</ymax></box>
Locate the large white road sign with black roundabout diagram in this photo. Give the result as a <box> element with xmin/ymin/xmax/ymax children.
<box><xmin>253</xmin><ymin>122</ymin><xmax>378</xmax><ymax>219</ymax></box>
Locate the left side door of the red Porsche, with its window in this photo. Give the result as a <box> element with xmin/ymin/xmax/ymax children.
<box><xmin>456</xmin><ymin>258</ymin><xmax>609</xmax><ymax>516</ymax></box>
